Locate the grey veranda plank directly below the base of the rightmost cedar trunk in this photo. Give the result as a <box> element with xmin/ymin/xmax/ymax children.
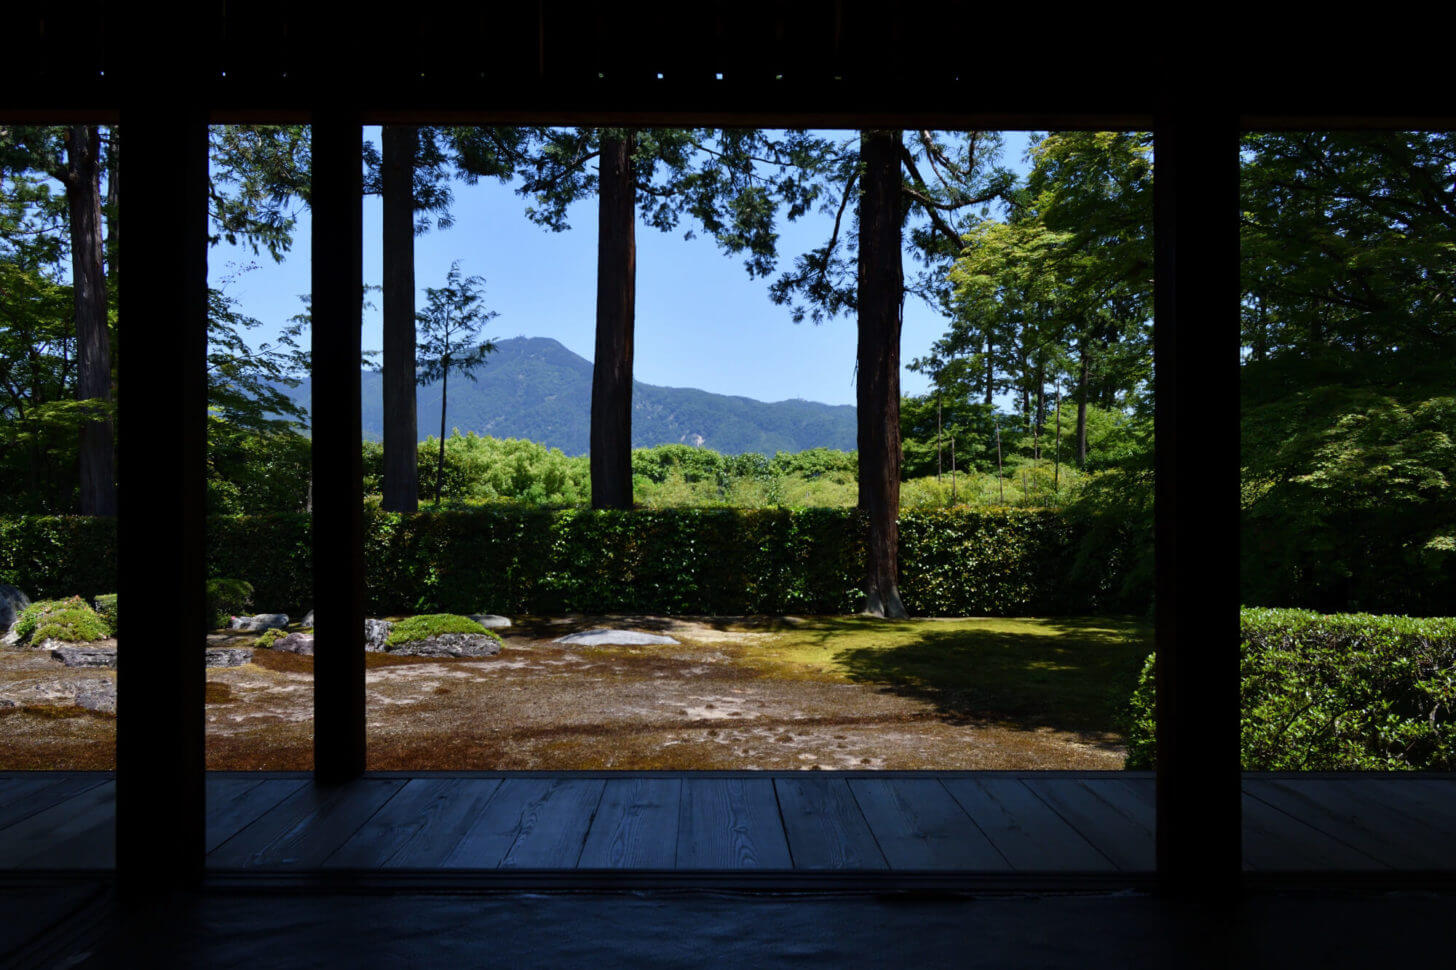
<box><xmin>849</xmin><ymin>778</ymin><xmax>1010</xmax><ymax>871</ymax></box>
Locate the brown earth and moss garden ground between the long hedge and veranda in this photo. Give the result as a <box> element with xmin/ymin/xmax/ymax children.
<box><xmin>0</xmin><ymin>616</ymin><xmax>1150</xmax><ymax>770</ymax></box>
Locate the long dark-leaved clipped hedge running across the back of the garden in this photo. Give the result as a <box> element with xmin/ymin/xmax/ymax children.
<box><xmin>0</xmin><ymin>505</ymin><xmax>1147</xmax><ymax>616</ymax></box>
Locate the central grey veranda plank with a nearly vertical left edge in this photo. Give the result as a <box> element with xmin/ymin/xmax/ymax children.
<box><xmin>677</xmin><ymin>778</ymin><xmax>794</xmax><ymax>870</ymax></box>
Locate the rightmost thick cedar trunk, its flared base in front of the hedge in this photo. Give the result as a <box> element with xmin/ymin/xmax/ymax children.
<box><xmin>855</xmin><ymin>131</ymin><xmax>906</xmax><ymax>619</ymax></box>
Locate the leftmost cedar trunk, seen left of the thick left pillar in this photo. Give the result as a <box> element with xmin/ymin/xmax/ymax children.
<box><xmin>66</xmin><ymin>125</ymin><xmax>116</xmax><ymax>516</ymax></box>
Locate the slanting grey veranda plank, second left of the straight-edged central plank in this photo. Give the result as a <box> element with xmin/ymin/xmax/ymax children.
<box><xmin>441</xmin><ymin>776</ymin><xmax>604</xmax><ymax>870</ymax></box>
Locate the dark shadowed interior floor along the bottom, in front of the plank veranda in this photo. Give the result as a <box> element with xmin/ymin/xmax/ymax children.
<box><xmin>8</xmin><ymin>886</ymin><xmax>1456</xmax><ymax>970</ymax></box>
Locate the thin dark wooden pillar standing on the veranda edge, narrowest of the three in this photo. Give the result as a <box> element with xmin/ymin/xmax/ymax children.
<box><xmin>312</xmin><ymin>106</ymin><xmax>364</xmax><ymax>784</ymax></box>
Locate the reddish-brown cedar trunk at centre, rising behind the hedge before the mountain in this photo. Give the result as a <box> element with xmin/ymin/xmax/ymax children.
<box><xmin>591</xmin><ymin>134</ymin><xmax>636</xmax><ymax>508</ymax></box>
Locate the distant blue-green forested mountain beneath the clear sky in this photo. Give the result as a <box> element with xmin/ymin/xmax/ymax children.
<box><xmin>278</xmin><ymin>336</ymin><xmax>855</xmax><ymax>454</ymax></box>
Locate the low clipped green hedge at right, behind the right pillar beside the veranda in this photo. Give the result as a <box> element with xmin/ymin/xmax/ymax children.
<box><xmin>1127</xmin><ymin>609</ymin><xmax>1456</xmax><ymax>772</ymax></box>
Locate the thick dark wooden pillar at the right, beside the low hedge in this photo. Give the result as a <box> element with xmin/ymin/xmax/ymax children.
<box><xmin>1153</xmin><ymin>106</ymin><xmax>1241</xmax><ymax>897</ymax></box>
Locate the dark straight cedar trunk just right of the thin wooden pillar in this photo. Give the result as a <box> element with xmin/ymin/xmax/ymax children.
<box><xmin>381</xmin><ymin>125</ymin><xmax>419</xmax><ymax>513</ymax></box>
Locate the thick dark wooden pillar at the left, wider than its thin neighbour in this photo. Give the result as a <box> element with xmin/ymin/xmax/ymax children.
<box><xmin>116</xmin><ymin>109</ymin><xmax>207</xmax><ymax>888</ymax></box>
